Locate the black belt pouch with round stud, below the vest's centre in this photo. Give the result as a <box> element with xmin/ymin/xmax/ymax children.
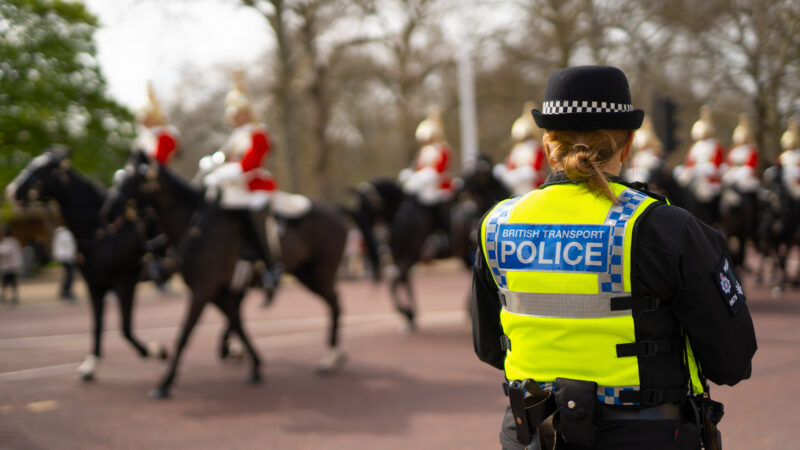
<box><xmin>555</xmin><ymin>378</ymin><xmax>597</xmax><ymax>447</ymax></box>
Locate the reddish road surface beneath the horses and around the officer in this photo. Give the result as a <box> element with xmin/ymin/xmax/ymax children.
<box><xmin>0</xmin><ymin>262</ymin><xmax>800</xmax><ymax>450</ymax></box>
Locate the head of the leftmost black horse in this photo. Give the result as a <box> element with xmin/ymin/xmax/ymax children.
<box><xmin>6</xmin><ymin>150</ymin><xmax>71</xmax><ymax>205</ymax></box>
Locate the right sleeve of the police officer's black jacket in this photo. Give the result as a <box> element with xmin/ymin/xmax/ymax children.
<box><xmin>672</xmin><ymin>215</ymin><xmax>757</xmax><ymax>385</ymax></box>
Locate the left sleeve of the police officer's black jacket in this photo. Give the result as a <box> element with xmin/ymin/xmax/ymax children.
<box><xmin>470</xmin><ymin>243</ymin><xmax>506</xmax><ymax>370</ymax></box>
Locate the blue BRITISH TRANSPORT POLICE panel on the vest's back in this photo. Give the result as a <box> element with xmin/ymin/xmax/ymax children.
<box><xmin>497</xmin><ymin>223</ymin><xmax>611</xmax><ymax>273</ymax></box>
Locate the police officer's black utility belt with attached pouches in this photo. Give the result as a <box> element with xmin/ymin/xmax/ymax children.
<box><xmin>503</xmin><ymin>378</ymin><xmax>688</xmax><ymax>447</ymax></box>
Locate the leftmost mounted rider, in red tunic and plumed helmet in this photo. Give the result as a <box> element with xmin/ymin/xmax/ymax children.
<box><xmin>133</xmin><ymin>81</ymin><xmax>180</xmax><ymax>165</ymax></box>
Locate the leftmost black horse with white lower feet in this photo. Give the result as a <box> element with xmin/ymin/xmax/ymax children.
<box><xmin>6</xmin><ymin>151</ymin><xmax>166</xmax><ymax>380</ymax></box>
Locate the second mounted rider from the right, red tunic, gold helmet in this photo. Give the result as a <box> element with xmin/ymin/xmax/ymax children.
<box><xmin>722</xmin><ymin>114</ymin><xmax>761</xmax><ymax>194</ymax></box>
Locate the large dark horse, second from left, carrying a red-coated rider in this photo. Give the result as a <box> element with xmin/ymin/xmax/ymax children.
<box><xmin>107</xmin><ymin>152</ymin><xmax>347</xmax><ymax>398</ymax></box>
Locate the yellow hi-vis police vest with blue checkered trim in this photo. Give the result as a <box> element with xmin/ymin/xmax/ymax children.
<box><xmin>481</xmin><ymin>183</ymin><xmax>694</xmax><ymax>404</ymax></box>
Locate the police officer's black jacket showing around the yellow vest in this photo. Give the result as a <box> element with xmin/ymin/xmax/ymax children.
<box><xmin>470</xmin><ymin>172</ymin><xmax>756</xmax><ymax>388</ymax></box>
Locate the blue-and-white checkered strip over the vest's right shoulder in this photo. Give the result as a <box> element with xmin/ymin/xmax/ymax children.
<box><xmin>598</xmin><ymin>189</ymin><xmax>647</xmax><ymax>293</ymax></box>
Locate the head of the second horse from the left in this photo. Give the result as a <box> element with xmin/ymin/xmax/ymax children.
<box><xmin>101</xmin><ymin>151</ymin><xmax>160</xmax><ymax>223</ymax></box>
